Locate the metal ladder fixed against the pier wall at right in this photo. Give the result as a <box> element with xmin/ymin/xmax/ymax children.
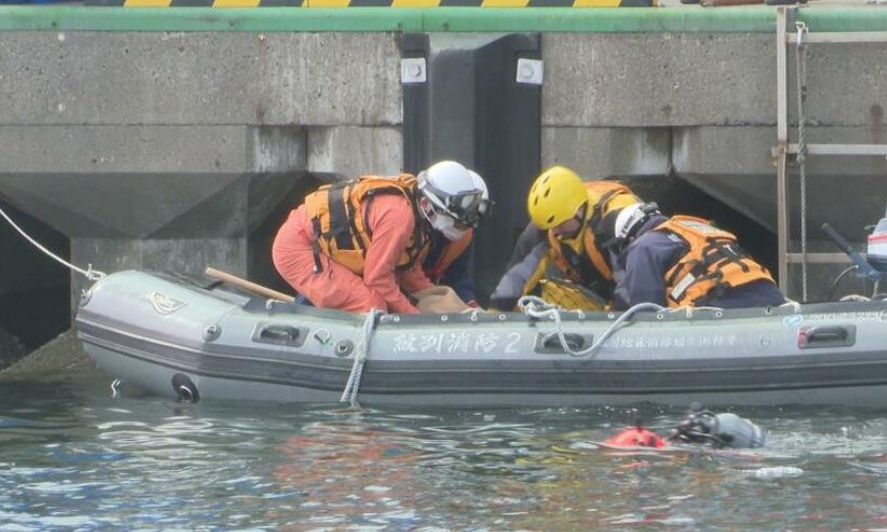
<box><xmin>773</xmin><ymin>6</ymin><xmax>887</xmax><ymax>300</ymax></box>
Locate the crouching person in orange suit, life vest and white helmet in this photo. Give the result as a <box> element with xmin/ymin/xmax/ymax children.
<box><xmin>272</xmin><ymin>161</ymin><xmax>485</xmax><ymax>314</ymax></box>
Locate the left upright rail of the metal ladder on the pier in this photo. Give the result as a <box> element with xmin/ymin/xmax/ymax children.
<box><xmin>776</xmin><ymin>7</ymin><xmax>789</xmax><ymax>295</ymax></box>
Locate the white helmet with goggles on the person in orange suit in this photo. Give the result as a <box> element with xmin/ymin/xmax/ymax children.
<box><xmin>417</xmin><ymin>161</ymin><xmax>490</xmax><ymax>227</ymax></box>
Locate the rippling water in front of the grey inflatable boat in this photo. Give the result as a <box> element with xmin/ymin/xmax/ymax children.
<box><xmin>0</xmin><ymin>370</ymin><xmax>887</xmax><ymax>531</ymax></box>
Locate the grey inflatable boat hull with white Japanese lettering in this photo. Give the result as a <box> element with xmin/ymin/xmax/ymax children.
<box><xmin>76</xmin><ymin>271</ymin><xmax>887</xmax><ymax>407</ymax></box>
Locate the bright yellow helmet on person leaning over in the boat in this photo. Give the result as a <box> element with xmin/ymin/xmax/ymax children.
<box><xmin>527</xmin><ymin>166</ymin><xmax>588</xmax><ymax>230</ymax></box>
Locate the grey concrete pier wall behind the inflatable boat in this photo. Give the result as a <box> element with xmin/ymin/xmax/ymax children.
<box><xmin>0</xmin><ymin>4</ymin><xmax>887</xmax><ymax>372</ymax></box>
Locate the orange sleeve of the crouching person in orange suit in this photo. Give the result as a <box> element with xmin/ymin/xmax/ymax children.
<box><xmin>363</xmin><ymin>194</ymin><xmax>431</xmax><ymax>314</ymax></box>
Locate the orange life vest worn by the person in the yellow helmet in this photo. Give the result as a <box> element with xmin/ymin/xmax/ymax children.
<box><xmin>548</xmin><ymin>181</ymin><xmax>640</xmax><ymax>287</ymax></box>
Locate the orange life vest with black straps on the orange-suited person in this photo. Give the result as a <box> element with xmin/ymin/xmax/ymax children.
<box><xmin>305</xmin><ymin>174</ymin><xmax>429</xmax><ymax>275</ymax></box>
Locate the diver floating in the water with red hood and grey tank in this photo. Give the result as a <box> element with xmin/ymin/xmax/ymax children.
<box><xmin>604</xmin><ymin>403</ymin><xmax>767</xmax><ymax>449</ymax></box>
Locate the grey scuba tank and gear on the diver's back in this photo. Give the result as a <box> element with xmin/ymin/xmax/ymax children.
<box><xmin>668</xmin><ymin>403</ymin><xmax>767</xmax><ymax>449</ymax></box>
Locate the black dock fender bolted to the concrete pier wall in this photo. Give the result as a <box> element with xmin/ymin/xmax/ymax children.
<box><xmin>400</xmin><ymin>35</ymin><xmax>544</xmax><ymax>303</ymax></box>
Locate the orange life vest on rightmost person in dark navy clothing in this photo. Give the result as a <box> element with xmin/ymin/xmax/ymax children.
<box><xmin>653</xmin><ymin>216</ymin><xmax>774</xmax><ymax>307</ymax></box>
